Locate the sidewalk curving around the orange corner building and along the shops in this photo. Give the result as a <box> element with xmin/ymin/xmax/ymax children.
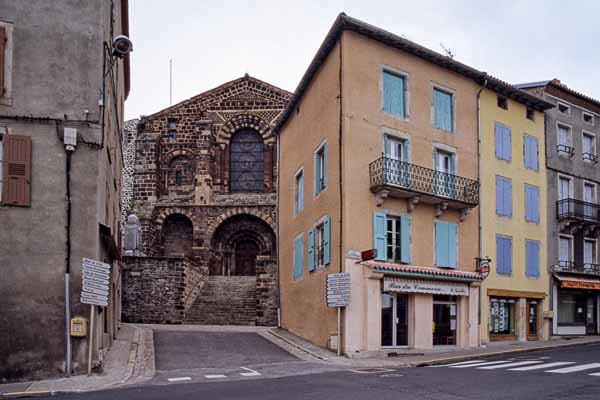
<box><xmin>269</xmin><ymin>328</ymin><xmax>600</xmax><ymax>368</ymax></box>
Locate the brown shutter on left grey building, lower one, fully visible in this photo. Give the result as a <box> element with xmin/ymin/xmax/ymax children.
<box><xmin>2</xmin><ymin>135</ymin><xmax>31</xmax><ymax>207</ymax></box>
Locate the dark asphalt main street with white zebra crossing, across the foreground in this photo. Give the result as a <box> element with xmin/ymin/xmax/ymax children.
<box><xmin>37</xmin><ymin>346</ymin><xmax>600</xmax><ymax>400</ymax></box>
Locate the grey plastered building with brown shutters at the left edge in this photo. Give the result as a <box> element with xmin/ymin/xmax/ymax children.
<box><xmin>0</xmin><ymin>0</ymin><xmax>130</xmax><ymax>382</ymax></box>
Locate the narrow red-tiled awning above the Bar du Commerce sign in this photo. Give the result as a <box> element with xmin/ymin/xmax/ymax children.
<box><xmin>363</xmin><ymin>261</ymin><xmax>483</xmax><ymax>282</ymax></box>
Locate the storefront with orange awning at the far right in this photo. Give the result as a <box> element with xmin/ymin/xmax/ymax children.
<box><xmin>553</xmin><ymin>274</ymin><xmax>600</xmax><ymax>335</ymax></box>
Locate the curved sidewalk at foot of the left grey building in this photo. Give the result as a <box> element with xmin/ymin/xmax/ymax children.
<box><xmin>0</xmin><ymin>324</ymin><xmax>154</xmax><ymax>398</ymax></box>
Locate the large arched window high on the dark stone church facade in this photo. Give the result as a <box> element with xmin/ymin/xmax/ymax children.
<box><xmin>229</xmin><ymin>129</ymin><xmax>264</xmax><ymax>192</ymax></box>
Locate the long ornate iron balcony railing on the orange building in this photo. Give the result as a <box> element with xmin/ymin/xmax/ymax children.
<box><xmin>369</xmin><ymin>157</ymin><xmax>479</xmax><ymax>207</ymax></box>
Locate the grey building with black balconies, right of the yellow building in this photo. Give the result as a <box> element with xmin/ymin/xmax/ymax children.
<box><xmin>517</xmin><ymin>79</ymin><xmax>600</xmax><ymax>335</ymax></box>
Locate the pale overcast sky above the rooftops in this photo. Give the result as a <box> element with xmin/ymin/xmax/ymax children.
<box><xmin>126</xmin><ymin>0</ymin><xmax>600</xmax><ymax>119</ymax></box>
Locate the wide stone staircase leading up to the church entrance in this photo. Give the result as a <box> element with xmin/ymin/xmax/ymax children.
<box><xmin>185</xmin><ymin>276</ymin><xmax>256</xmax><ymax>325</ymax></box>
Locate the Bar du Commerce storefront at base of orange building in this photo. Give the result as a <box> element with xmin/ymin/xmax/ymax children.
<box><xmin>345</xmin><ymin>263</ymin><xmax>480</xmax><ymax>353</ymax></box>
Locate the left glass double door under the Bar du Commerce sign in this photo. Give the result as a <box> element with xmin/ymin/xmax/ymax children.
<box><xmin>381</xmin><ymin>293</ymin><xmax>408</xmax><ymax>347</ymax></box>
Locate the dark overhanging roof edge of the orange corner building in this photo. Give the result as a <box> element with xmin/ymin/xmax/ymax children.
<box><xmin>274</xmin><ymin>13</ymin><xmax>554</xmax><ymax>133</ymax></box>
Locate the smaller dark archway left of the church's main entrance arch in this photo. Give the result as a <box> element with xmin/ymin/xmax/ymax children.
<box><xmin>161</xmin><ymin>214</ymin><xmax>194</xmax><ymax>257</ymax></box>
